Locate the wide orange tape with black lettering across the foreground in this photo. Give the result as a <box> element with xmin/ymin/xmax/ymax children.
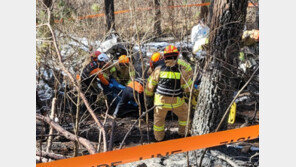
<box><xmin>36</xmin><ymin>125</ymin><xmax>259</xmax><ymax>167</ymax></box>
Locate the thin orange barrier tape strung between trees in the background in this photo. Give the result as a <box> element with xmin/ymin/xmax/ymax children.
<box><xmin>54</xmin><ymin>2</ymin><xmax>257</xmax><ymax>23</ymax></box>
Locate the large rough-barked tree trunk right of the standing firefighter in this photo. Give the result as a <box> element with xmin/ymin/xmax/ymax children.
<box><xmin>192</xmin><ymin>0</ymin><xmax>248</xmax><ymax>135</ymax></box>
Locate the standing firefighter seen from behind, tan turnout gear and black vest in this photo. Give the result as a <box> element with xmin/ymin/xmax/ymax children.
<box><xmin>145</xmin><ymin>45</ymin><xmax>192</xmax><ymax>141</ymax></box>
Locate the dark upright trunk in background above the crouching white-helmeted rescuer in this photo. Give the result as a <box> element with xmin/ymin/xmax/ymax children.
<box><xmin>104</xmin><ymin>0</ymin><xmax>115</xmax><ymax>32</ymax></box>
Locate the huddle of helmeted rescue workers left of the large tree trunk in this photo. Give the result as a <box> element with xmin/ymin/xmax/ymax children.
<box><xmin>79</xmin><ymin>45</ymin><xmax>197</xmax><ymax>141</ymax></box>
